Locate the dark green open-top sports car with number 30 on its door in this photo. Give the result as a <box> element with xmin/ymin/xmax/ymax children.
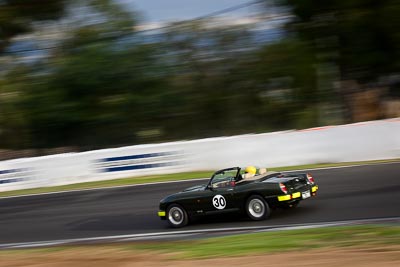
<box><xmin>158</xmin><ymin>166</ymin><xmax>318</xmax><ymax>228</ymax></box>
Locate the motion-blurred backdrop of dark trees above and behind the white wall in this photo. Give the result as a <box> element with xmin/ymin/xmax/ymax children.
<box><xmin>0</xmin><ymin>0</ymin><xmax>400</xmax><ymax>160</ymax></box>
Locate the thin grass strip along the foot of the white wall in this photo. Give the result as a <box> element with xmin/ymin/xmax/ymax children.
<box><xmin>0</xmin><ymin>159</ymin><xmax>400</xmax><ymax>197</ymax></box>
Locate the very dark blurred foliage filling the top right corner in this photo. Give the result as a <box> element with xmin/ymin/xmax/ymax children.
<box><xmin>278</xmin><ymin>0</ymin><xmax>400</xmax><ymax>82</ymax></box>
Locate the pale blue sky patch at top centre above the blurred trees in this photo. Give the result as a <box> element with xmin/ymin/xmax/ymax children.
<box><xmin>118</xmin><ymin>0</ymin><xmax>254</xmax><ymax>23</ymax></box>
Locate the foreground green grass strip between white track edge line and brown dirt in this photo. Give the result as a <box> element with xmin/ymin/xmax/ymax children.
<box><xmin>0</xmin><ymin>225</ymin><xmax>400</xmax><ymax>259</ymax></box>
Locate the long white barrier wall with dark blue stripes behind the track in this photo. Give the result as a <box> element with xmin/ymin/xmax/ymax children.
<box><xmin>0</xmin><ymin>118</ymin><xmax>400</xmax><ymax>191</ymax></box>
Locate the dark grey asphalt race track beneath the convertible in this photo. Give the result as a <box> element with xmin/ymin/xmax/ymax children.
<box><xmin>0</xmin><ymin>163</ymin><xmax>400</xmax><ymax>244</ymax></box>
